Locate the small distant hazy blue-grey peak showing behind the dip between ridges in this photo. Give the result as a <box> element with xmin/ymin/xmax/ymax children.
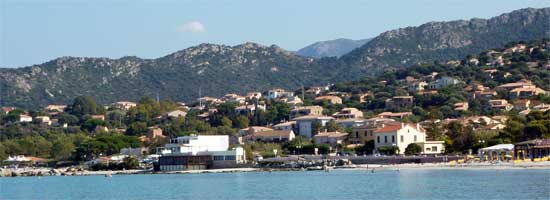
<box><xmin>296</xmin><ymin>38</ymin><xmax>370</xmax><ymax>58</ymax></box>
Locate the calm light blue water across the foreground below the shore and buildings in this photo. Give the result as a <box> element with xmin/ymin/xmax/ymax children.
<box><xmin>0</xmin><ymin>169</ymin><xmax>550</xmax><ymax>200</ymax></box>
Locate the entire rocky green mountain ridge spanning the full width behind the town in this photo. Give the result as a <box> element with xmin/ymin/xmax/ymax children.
<box><xmin>0</xmin><ymin>8</ymin><xmax>550</xmax><ymax>107</ymax></box>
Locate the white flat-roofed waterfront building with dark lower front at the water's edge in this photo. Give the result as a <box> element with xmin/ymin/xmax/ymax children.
<box><xmin>156</xmin><ymin>135</ymin><xmax>246</xmax><ymax>171</ymax></box>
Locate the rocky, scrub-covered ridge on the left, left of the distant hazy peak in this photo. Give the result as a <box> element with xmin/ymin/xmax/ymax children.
<box><xmin>0</xmin><ymin>43</ymin><xmax>350</xmax><ymax>107</ymax></box>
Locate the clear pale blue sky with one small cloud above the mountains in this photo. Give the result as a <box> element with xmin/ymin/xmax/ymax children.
<box><xmin>0</xmin><ymin>0</ymin><xmax>550</xmax><ymax>68</ymax></box>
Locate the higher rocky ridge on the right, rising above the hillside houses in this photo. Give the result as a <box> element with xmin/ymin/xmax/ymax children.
<box><xmin>342</xmin><ymin>8</ymin><xmax>550</xmax><ymax>74</ymax></box>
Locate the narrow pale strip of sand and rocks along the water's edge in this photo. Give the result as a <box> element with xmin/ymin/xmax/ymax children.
<box><xmin>4</xmin><ymin>161</ymin><xmax>550</xmax><ymax>177</ymax></box>
